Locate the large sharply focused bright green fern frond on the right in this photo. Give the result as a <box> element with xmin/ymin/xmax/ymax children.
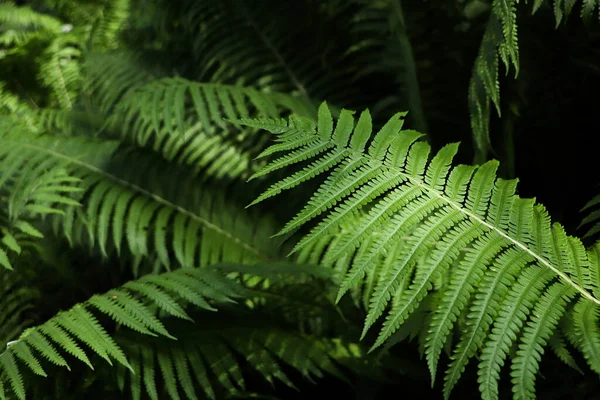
<box><xmin>238</xmin><ymin>103</ymin><xmax>600</xmax><ymax>399</ymax></box>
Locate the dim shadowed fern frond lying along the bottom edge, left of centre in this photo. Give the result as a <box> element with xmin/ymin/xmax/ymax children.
<box><xmin>119</xmin><ymin>313</ymin><xmax>375</xmax><ymax>399</ymax></box>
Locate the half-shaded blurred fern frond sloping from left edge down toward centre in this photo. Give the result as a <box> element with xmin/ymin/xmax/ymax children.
<box><xmin>0</xmin><ymin>126</ymin><xmax>277</xmax><ymax>274</ymax></box>
